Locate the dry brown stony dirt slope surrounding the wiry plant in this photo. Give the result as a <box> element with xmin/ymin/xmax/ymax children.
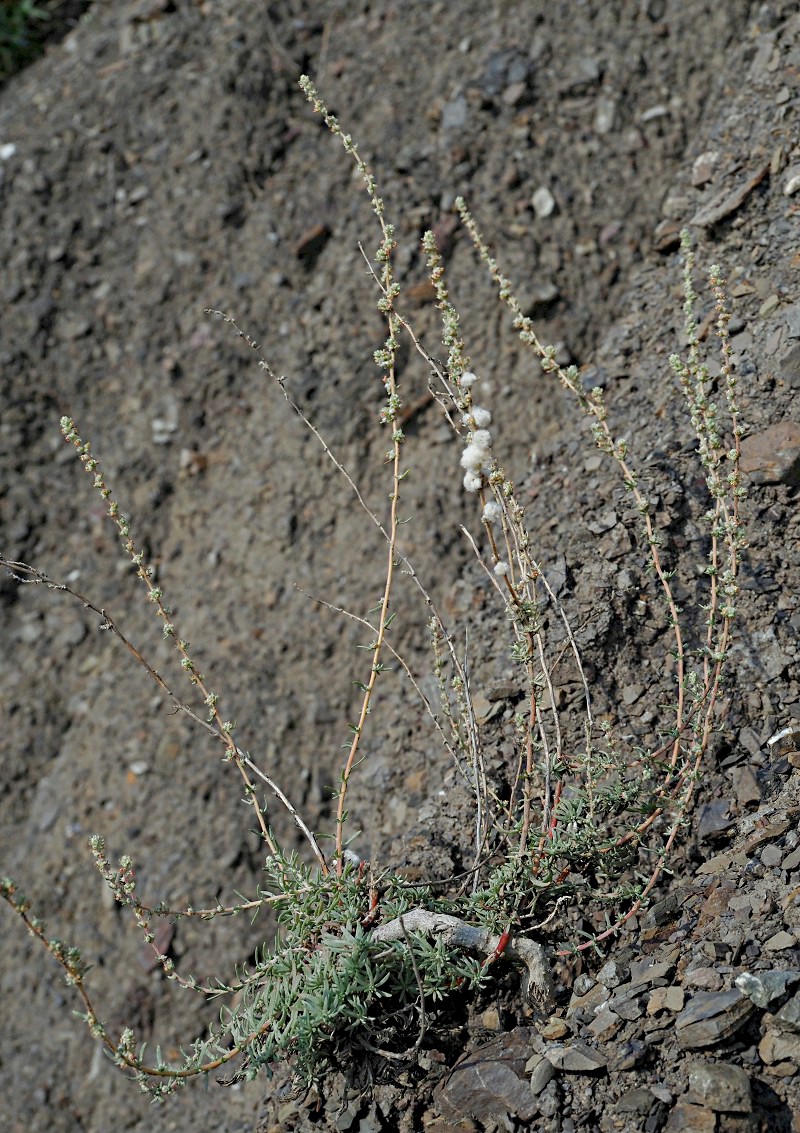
<box><xmin>0</xmin><ymin>0</ymin><xmax>800</xmax><ymax>1133</ymax></box>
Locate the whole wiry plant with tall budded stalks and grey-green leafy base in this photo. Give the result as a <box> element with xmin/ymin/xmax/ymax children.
<box><xmin>0</xmin><ymin>80</ymin><xmax>742</xmax><ymax>1098</ymax></box>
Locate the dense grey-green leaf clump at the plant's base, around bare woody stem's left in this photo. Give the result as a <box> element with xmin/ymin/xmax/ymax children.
<box><xmin>95</xmin><ymin>843</ymin><xmax>487</xmax><ymax>1096</ymax></box>
